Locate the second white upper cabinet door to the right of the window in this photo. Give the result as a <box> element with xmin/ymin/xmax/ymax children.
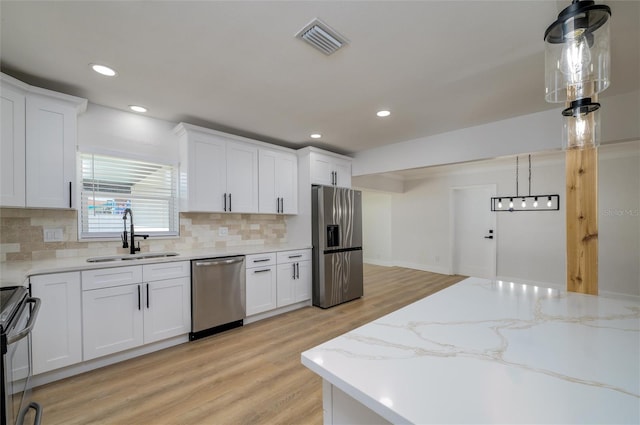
<box><xmin>227</xmin><ymin>142</ymin><xmax>258</xmax><ymax>213</ymax></box>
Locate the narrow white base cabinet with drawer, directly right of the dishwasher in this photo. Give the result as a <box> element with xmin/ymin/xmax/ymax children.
<box><xmin>245</xmin><ymin>252</ymin><xmax>276</xmax><ymax>316</ymax></box>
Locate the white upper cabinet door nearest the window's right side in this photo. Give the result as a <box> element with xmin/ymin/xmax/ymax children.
<box><xmin>188</xmin><ymin>134</ymin><xmax>227</xmax><ymax>212</ymax></box>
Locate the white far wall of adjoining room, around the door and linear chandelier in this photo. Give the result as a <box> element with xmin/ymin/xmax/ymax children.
<box><xmin>354</xmin><ymin>142</ymin><xmax>640</xmax><ymax>296</ymax></box>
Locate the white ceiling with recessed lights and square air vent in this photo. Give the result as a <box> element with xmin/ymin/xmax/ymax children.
<box><xmin>0</xmin><ymin>0</ymin><xmax>640</xmax><ymax>153</ymax></box>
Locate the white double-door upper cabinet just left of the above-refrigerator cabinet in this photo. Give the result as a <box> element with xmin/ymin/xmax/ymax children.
<box><xmin>258</xmin><ymin>149</ymin><xmax>298</xmax><ymax>214</ymax></box>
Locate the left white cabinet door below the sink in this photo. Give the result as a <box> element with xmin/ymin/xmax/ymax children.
<box><xmin>82</xmin><ymin>284</ymin><xmax>143</xmax><ymax>360</ymax></box>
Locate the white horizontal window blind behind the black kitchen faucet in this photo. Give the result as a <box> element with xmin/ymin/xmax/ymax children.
<box><xmin>79</xmin><ymin>153</ymin><xmax>179</xmax><ymax>239</ymax></box>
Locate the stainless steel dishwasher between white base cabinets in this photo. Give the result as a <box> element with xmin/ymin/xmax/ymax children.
<box><xmin>189</xmin><ymin>256</ymin><xmax>246</xmax><ymax>341</ymax></box>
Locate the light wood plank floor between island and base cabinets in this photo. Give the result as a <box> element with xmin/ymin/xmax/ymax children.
<box><xmin>33</xmin><ymin>265</ymin><xmax>464</xmax><ymax>425</ymax></box>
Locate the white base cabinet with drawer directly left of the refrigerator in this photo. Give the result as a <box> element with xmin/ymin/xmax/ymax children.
<box><xmin>277</xmin><ymin>249</ymin><xmax>311</xmax><ymax>307</ymax></box>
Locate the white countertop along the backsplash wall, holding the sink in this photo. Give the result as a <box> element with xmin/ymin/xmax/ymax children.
<box><xmin>0</xmin><ymin>244</ymin><xmax>311</xmax><ymax>287</ymax></box>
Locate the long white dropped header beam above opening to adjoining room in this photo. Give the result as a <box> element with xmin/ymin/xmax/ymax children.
<box><xmin>353</xmin><ymin>91</ymin><xmax>640</xmax><ymax>176</ymax></box>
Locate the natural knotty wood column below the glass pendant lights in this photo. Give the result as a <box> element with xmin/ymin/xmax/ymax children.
<box><xmin>566</xmin><ymin>147</ymin><xmax>598</xmax><ymax>295</ymax></box>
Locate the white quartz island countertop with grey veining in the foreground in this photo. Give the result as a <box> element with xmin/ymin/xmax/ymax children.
<box><xmin>302</xmin><ymin>278</ymin><xmax>640</xmax><ymax>424</ymax></box>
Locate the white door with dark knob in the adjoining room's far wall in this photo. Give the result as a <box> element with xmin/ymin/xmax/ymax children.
<box><xmin>451</xmin><ymin>185</ymin><xmax>496</xmax><ymax>278</ymax></box>
